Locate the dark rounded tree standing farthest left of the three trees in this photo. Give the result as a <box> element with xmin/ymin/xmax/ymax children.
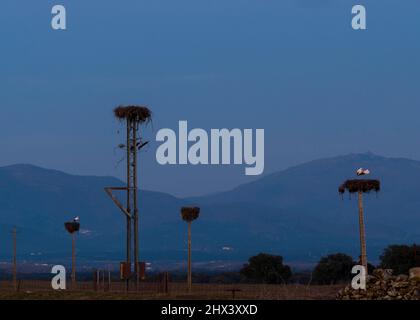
<box><xmin>241</xmin><ymin>253</ymin><xmax>292</xmax><ymax>284</ymax></box>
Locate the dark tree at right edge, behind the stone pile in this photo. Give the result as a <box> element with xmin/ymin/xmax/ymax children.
<box><xmin>380</xmin><ymin>244</ymin><xmax>420</xmax><ymax>275</ymax></box>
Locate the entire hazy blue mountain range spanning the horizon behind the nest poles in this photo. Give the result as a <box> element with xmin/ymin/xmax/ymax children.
<box><xmin>0</xmin><ymin>153</ymin><xmax>420</xmax><ymax>268</ymax></box>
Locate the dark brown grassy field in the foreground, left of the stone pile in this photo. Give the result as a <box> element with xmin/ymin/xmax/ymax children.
<box><xmin>0</xmin><ymin>280</ymin><xmax>344</xmax><ymax>300</ymax></box>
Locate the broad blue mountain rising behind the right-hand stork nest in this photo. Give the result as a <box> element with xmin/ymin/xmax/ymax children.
<box><xmin>195</xmin><ymin>153</ymin><xmax>420</xmax><ymax>260</ymax></box>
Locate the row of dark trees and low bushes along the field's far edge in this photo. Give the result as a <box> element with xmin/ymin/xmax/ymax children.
<box><xmin>162</xmin><ymin>244</ymin><xmax>420</xmax><ymax>285</ymax></box>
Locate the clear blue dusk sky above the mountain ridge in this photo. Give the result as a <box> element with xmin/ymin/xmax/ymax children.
<box><xmin>0</xmin><ymin>0</ymin><xmax>420</xmax><ymax>196</ymax></box>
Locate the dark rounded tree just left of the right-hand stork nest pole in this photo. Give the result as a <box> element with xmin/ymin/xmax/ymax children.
<box><xmin>313</xmin><ymin>253</ymin><xmax>357</xmax><ymax>284</ymax></box>
